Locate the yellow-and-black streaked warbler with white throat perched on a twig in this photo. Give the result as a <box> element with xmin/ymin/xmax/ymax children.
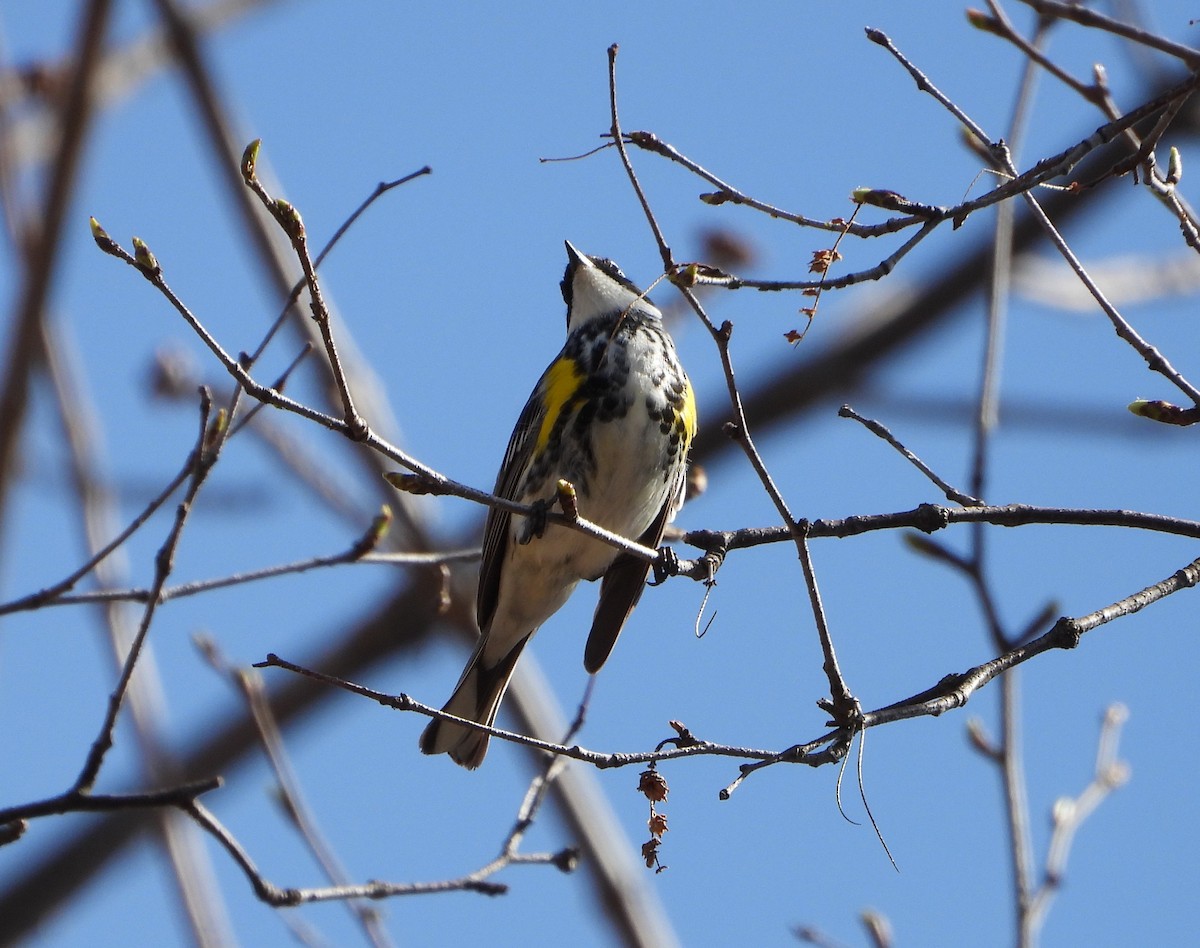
<box><xmin>421</xmin><ymin>241</ymin><xmax>696</xmax><ymax>769</ymax></box>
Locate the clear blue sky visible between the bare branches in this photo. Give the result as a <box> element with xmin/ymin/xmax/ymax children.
<box><xmin>0</xmin><ymin>0</ymin><xmax>1200</xmax><ymax>946</ymax></box>
